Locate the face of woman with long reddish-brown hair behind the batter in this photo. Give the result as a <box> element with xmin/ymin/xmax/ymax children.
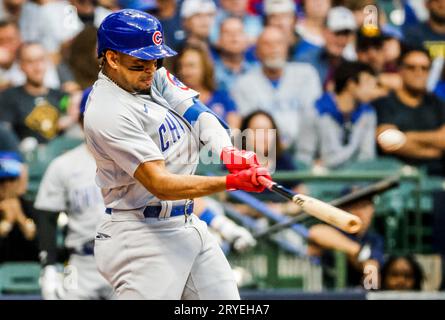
<box><xmin>178</xmin><ymin>50</ymin><xmax>204</xmax><ymax>90</ymax></box>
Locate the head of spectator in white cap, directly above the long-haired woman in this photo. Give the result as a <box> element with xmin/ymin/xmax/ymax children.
<box><xmin>181</xmin><ymin>0</ymin><xmax>216</xmax><ymax>46</ymax></box>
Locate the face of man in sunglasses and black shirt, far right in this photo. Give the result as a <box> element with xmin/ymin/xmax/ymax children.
<box><xmin>400</xmin><ymin>52</ymin><xmax>431</xmax><ymax>92</ymax></box>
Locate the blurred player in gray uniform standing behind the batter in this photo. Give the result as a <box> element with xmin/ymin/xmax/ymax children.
<box><xmin>34</xmin><ymin>91</ymin><xmax>113</xmax><ymax>300</ymax></box>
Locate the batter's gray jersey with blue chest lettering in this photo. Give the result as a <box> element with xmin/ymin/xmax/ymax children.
<box><xmin>84</xmin><ymin>68</ymin><xmax>199</xmax><ymax>210</ymax></box>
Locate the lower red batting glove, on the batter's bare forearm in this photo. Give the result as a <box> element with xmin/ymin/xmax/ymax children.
<box><xmin>226</xmin><ymin>167</ymin><xmax>272</xmax><ymax>192</ymax></box>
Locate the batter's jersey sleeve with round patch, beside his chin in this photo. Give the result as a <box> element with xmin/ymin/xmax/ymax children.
<box><xmin>153</xmin><ymin>68</ymin><xmax>199</xmax><ymax>109</ymax></box>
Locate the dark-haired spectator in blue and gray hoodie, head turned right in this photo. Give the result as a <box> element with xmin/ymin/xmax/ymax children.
<box><xmin>308</xmin><ymin>62</ymin><xmax>377</xmax><ymax>168</ymax></box>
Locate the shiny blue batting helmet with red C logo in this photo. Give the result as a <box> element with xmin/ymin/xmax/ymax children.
<box><xmin>97</xmin><ymin>9</ymin><xmax>177</xmax><ymax>60</ymax></box>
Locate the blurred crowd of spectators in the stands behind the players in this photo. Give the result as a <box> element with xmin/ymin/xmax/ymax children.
<box><xmin>0</xmin><ymin>0</ymin><xmax>445</xmax><ymax>296</ymax></box>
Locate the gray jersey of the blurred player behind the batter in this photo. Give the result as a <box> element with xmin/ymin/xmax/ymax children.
<box><xmin>34</xmin><ymin>144</ymin><xmax>105</xmax><ymax>249</ymax></box>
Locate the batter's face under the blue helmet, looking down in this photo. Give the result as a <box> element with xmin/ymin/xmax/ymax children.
<box><xmin>115</xmin><ymin>53</ymin><xmax>156</xmax><ymax>93</ymax></box>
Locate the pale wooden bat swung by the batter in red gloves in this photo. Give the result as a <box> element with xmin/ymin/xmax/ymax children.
<box><xmin>258</xmin><ymin>176</ymin><xmax>362</xmax><ymax>233</ymax></box>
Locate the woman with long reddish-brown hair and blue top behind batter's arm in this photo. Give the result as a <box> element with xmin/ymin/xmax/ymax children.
<box><xmin>174</xmin><ymin>46</ymin><xmax>241</xmax><ymax>128</ymax></box>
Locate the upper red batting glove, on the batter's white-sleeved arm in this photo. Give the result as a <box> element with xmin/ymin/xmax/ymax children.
<box><xmin>220</xmin><ymin>147</ymin><xmax>260</xmax><ymax>173</ymax></box>
